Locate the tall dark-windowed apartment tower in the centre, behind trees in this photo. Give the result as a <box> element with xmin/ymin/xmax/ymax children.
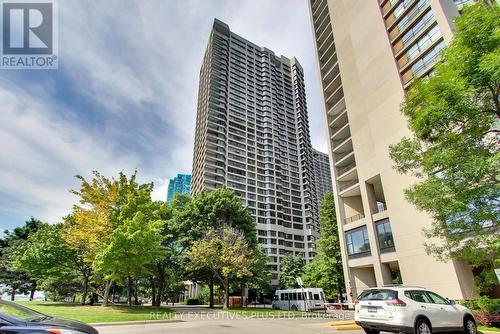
<box><xmin>191</xmin><ymin>19</ymin><xmax>318</xmax><ymax>284</ymax></box>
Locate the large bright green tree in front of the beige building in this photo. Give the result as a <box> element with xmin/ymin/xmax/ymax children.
<box><xmin>390</xmin><ymin>1</ymin><xmax>500</xmax><ymax>288</ymax></box>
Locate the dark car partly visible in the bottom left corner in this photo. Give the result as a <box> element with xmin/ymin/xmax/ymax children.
<box><xmin>0</xmin><ymin>300</ymin><xmax>97</xmax><ymax>334</ymax></box>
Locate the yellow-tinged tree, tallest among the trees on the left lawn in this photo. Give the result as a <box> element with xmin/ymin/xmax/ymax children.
<box><xmin>63</xmin><ymin>171</ymin><xmax>153</xmax><ymax>304</ymax></box>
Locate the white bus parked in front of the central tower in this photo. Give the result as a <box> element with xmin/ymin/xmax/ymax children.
<box><xmin>273</xmin><ymin>288</ymin><xmax>325</xmax><ymax>311</ymax></box>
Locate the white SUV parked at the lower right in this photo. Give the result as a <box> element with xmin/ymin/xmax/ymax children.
<box><xmin>354</xmin><ymin>286</ymin><xmax>477</xmax><ymax>334</ymax></box>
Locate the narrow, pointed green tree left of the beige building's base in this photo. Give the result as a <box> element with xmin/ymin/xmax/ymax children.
<box><xmin>302</xmin><ymin>193</ymin><xmax>344</xmax><ymax>300</ymax></box>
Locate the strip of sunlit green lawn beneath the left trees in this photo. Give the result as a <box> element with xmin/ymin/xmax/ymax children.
<box><xmin>17</xmin><ymin>302</ymin><xmax>174</xmax><ymax>323</ymax></box>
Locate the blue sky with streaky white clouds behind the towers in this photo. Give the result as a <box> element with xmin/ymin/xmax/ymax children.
<box><xmin>0</xmin><ymin>0</ymin><xmax>326</xmax><ymax>230</ymax></box>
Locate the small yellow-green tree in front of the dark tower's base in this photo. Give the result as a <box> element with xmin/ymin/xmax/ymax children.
<box><xmin>188</xmin><ymin>227</ymin><xmax>258</xmax><ymax>309</ymax></box>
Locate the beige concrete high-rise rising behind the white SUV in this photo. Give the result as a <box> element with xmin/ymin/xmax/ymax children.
<box><xmin>309</xmin><ymin>0</ymin><xmax>473</xmax><ymax>299</ymax></box>
